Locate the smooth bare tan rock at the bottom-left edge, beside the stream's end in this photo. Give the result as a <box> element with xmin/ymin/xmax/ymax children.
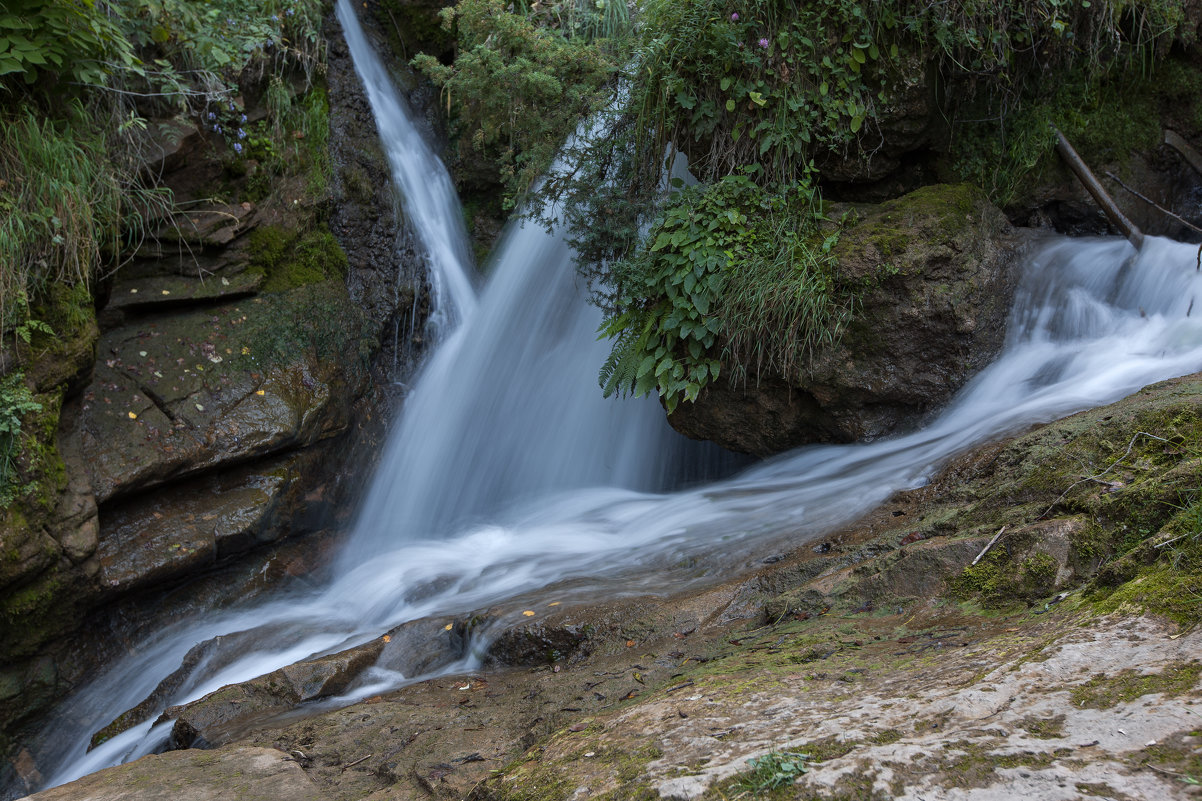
<box><xmin>29</xmin><ymin>748</ymin><xmax>323</xmax><ymax>801</ymax></box>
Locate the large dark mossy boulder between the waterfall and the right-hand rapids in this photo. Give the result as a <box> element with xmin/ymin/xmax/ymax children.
<box><xmin>668</xmin><ymin>185</ymin><xmax>1024</xmax><ymax>456</ymax></box>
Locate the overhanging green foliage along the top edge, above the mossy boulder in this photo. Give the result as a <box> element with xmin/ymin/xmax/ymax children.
<box><xmin>630</xmin><ymin>0</ymin><xmax>1191</xmax><ymax>192</ymax></box>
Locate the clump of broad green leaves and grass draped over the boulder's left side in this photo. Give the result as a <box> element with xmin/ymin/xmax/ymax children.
<box><xmin>600</xmin><ymin>167</ymin><xmax>852</xmax><ymax>413</ymax></box>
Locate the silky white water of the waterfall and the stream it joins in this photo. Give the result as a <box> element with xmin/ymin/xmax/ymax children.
<box><xmin>18</xmin><ymin>6</ymin><xmax>1202</xmax><ymax>784</ymax></box>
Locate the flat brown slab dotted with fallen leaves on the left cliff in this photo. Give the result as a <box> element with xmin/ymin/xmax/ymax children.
<box><xmin>81</xmin><ymin>285</ymin><xmax>365</xmax><ymax>503</ymax></box>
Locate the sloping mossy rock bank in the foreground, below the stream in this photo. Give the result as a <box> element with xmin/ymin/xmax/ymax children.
<box><xmin>18</xmin><ymin>376</ymin><xmax>1202</xmax><ymax>800</ymax></box>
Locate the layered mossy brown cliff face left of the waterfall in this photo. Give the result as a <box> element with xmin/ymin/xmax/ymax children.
<box><xmin>0</xmin><ymin>9</ymin><xmax>427</xmax><ymax>779</ymax></box>
